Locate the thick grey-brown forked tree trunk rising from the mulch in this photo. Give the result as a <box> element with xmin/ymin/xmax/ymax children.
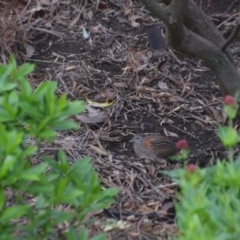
<box><xmin>141</xmin><ymin>0</ymin><xmax>240</xmax><ymax>96</ymax></box>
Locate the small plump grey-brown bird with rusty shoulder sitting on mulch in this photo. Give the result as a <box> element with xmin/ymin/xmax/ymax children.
<box><xmin>130</xmin><ymin>134</ymin><xmax>178</xmax><ymax>159</ymax></box>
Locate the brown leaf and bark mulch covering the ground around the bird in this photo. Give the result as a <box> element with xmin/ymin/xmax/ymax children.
<box><xmin>0</xmin><ymin>0</ymin><xmax>240</xmax><ymax>239</ymax></box>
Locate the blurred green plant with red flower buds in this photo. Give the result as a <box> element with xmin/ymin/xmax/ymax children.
<box><xmin>167</xmin><ymin>96</ymin><xmax>240</xmax><ymax>240</ymax></box>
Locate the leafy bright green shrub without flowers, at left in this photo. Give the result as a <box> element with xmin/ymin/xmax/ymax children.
<box><xmin>0</xmin><ymin>57</ymin><xmax>117</xmax><ymax>240</ymax></box>
